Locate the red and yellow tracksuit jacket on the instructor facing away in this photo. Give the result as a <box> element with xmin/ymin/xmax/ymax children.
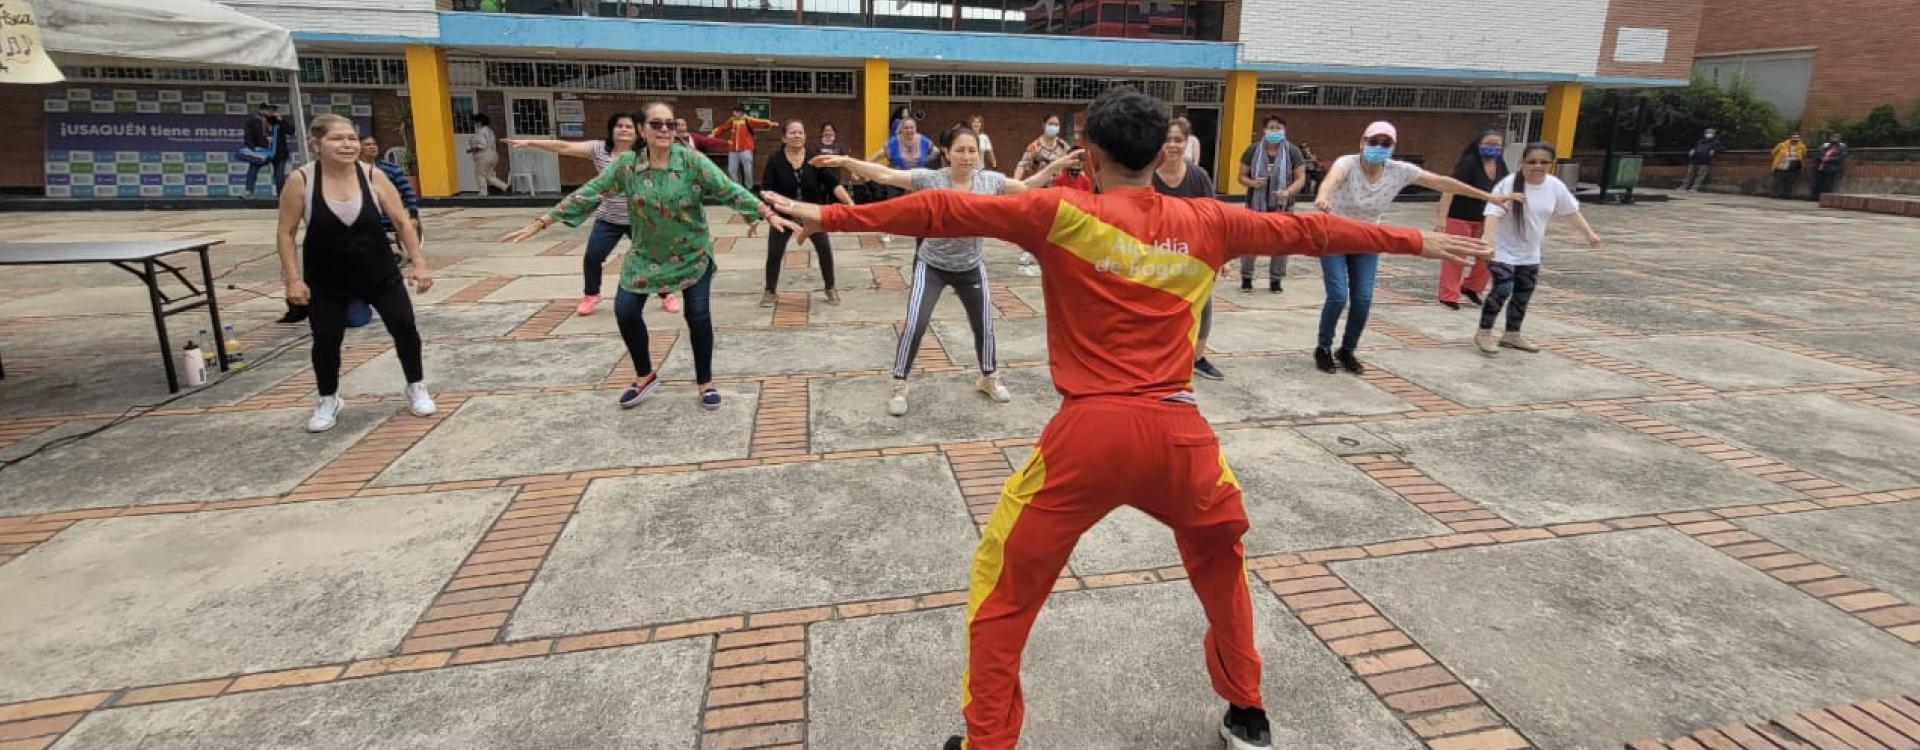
<box><xmin>820</xmin><ymin>186</ymin><xmax>1423</xmax><ymax>399</ymax></box>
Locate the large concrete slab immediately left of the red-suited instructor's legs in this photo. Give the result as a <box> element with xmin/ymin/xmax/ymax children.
<box><xmin>509</xmin><ymin>455</ymin><xmax>977</xmax><ymax>637</ymax></box>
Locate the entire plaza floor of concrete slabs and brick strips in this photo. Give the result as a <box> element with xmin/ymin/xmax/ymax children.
<box><xmin>0</xmin><ymin>196</ymin><xmax>1920</xmax><ymax>750</ymax></box>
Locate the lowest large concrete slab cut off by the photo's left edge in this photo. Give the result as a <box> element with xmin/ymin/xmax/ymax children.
<box><xmin>0</xmin><ymin>491</ymin><xmax>513</xmax><ymax>700</ymax></box>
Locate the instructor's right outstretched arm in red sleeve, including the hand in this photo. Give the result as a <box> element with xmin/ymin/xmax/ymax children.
<box><xmin>1212</xmin><ymin>205</ymin><xmax>1492</xmax><ymax>263</ymax></box>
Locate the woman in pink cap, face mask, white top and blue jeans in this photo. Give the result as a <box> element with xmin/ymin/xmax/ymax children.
<box><xmin>1313</xmin><ymin>121</ymin><xmax>1515</xmax><ymax>374</ymax></box>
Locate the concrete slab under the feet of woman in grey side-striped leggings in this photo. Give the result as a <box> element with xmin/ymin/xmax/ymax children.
<box><xmin>808</xmin><ymin>368</ymin><xmax>1060</xmax><ymax>451</ymax></box>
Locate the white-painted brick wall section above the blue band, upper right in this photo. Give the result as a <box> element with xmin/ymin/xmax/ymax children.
<box><xmin>1240</xmin><ymin>0</ymin><xmax>1611</xmax><ymax>75</ymax></box>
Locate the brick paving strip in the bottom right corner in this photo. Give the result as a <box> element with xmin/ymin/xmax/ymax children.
<box><xmin>1609</xmin><ymin>696</ymin><xmax>1920</xmax><ymax>750</ymax></box>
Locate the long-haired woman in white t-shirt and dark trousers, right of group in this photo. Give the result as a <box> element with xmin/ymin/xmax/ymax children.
<box><xmin>1473</xmin><ymin>144</ymin><xmax>1599</xmax><ymax>355</ymax></box>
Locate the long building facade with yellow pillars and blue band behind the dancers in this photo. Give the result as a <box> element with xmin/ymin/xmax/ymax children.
<box><xmin>0</xmin><ymin>0</ymin><xmax>1699</xmax><ymax>196</ymax></box>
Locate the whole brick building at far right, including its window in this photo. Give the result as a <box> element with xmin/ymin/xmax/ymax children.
<box><xmin>1693</xmin><ymin>0</ymin><xmax>1920</xmax><ymax>129</ymax></box>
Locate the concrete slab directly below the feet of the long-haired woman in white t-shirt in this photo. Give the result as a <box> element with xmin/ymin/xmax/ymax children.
<box><xmin>1365</xmin><ymin>345</ymin><xmax>1667</xmax><ymax>407</ymax></box>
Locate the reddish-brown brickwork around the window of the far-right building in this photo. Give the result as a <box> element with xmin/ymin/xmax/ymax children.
<box><xmin>1697</xmin><ymin>0</ymin><xmax>1920</xmax><ymax>127</ymax></box>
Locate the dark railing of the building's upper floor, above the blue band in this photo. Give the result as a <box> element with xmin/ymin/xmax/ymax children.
<box><xmin>453</xmin><ymin>0</ymin><xmax>1225</xmax><ymax>42</ymax></box>
